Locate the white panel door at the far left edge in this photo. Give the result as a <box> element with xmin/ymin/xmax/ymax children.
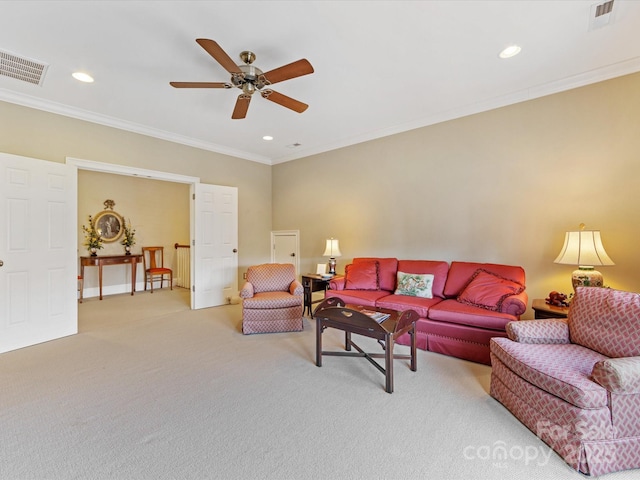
<box><xmin>0</xmin><ymin>153</ymin><xmax>78</xmax><ymax>352</ymax></box>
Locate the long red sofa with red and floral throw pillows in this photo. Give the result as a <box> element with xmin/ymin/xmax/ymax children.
<box><xmin>325</xmin><ymin>257</ymin><xmax>528</xmax><ymax>365</ymax></box>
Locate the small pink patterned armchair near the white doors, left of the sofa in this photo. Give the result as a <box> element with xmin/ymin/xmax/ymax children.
<box><xmin>240</xmin><ymin>263</ymin><xmax>303</xmax><ymax>335</ymax></box>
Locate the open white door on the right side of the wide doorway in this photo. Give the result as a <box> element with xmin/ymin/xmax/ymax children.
<box><xmin>191</xmin><ymin>183</ymin><xmax>238</xmax><ymax>309</ymax></box>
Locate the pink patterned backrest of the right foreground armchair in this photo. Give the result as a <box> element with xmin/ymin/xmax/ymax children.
<box><xmin>569</xmin><ymin>287</ymin><xmax>640</xmax><ymax>358</ymax></box>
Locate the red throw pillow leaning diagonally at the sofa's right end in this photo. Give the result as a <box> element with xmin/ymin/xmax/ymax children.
<box><xmin>458</xmin><ymin>269</ymin><xmax>524</xmax><ymax>312</ymax></box>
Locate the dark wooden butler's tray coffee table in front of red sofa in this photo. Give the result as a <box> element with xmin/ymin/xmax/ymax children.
<box><xmin>314</xmin><ymin>297</ymin><xmax>418</xmax><ymax>393</ymax></box>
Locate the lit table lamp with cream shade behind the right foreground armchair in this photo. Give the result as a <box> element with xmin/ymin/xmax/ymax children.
<box><xmin>554</xmin><ymin>223</ymin><xmax>615</xmax><ymax>292</ymax></box>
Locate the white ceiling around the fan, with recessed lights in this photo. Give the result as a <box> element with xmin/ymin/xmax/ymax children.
<box><xmin>0</xmin><ymin>0</ymin><xmax>640</xmax><ymax>164</ymax></box>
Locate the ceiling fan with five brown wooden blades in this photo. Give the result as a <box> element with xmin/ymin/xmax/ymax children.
<box><xmin>169</xmin><ymin>38</ymin><xmax>313</xmax><ymax>120</ymax></box>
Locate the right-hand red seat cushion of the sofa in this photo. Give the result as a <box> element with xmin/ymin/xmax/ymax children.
<box><xmin>429</xmin><ymin>298</ymin><xmax>516</xmax><ymax>332</ymax></box>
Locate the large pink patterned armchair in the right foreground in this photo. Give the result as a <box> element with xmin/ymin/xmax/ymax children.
<box><xmin>491</xmin><ymin>287</ymin><xmax>640</xmax><ymax>476</ymax></box>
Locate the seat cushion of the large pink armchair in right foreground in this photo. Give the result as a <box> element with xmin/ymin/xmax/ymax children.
<box><xmin>491</xmin><ymin>338</ymin><xmax>608</xmax><ymax>408</ymax></box>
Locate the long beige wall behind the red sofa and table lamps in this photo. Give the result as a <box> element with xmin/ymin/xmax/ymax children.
<box><xmin>273</xmin><ymin>74</ymin><xmax>640</xmax><ymax>317</ymax></box>
